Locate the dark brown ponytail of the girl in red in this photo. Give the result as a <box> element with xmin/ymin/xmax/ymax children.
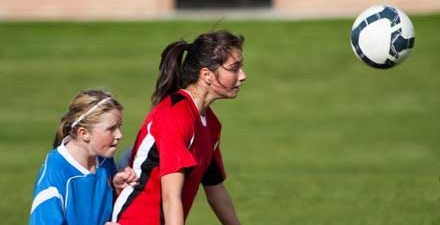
<box><xmin>151</xmin><ymin>40</ymin><xmax>189</xmax><ymax>106</ymax></box>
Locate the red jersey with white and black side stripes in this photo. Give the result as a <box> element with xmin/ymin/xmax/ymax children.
<box><xmin>113</xmin><ymin>90</ymin><xmax>226</xmax><ymax>225</ymax></box>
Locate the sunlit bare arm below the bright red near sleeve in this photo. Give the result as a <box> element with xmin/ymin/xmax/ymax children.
<box><xmin>161</xmin><ymin>172</ymin><xmax>185</xmax><ymax>225</ymax></box>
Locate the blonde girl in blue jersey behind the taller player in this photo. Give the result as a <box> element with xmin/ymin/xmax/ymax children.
<box><xmin>29</xmin><ymin>90</ymin><xmax>137</xmax><ymax>225</ymax></box>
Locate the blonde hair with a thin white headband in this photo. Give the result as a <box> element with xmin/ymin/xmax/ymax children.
<box><xmin>53</xmin><ymin>89</ymin><xmax>123</xmax><ymax>148</ymax></box>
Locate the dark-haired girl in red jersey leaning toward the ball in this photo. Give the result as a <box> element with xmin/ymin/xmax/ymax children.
<box><xmin>113</xmin><ymin>31</ymin><xmax>246</xmax><ymax>225</ymax></box>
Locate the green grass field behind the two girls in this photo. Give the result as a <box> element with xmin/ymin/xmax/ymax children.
<box><xmin>0</xmin><ymin>15</ymin><xmax>440</xmax><ymax>225</ymax></box>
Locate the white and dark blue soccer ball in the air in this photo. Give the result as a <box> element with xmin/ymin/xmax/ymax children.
<box><xmin>351</xmin><ymin>5</ymin><xmax>415</xmax><ymax>69</ymax></box>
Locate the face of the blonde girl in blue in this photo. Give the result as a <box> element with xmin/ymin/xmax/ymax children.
<box><xmin>89</xmin><ymin>109</ymin><xmax>122</xmax><ymax>158</ymax></box>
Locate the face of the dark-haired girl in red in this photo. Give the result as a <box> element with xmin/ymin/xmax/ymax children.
<box><xmin>212</xmin><ymin>49</ymin><xmax>246</xmax><ymax>98</ymax></box>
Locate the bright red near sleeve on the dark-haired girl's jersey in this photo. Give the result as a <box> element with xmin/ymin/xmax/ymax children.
<box><xmin>155</xmin><ymin>104</ymin><xmax>197</xmax><ymax>176</ymax></box>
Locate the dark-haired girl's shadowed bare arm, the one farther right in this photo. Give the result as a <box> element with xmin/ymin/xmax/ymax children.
<box><xmin>205</xmin><ymin>183</ymin><xmax>240</xmax><ymax>225</ymax></box>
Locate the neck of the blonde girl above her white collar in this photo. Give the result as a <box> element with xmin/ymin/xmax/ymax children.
<box><xmin>66</xmin><ymin>140</ymin><xmax>96</xmax><ymax>172</ymax></box>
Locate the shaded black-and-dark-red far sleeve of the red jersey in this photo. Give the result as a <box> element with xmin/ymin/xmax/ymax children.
<box><xmin>202</xmin><ymin>148</ymin><xmax>226</xmax><ymax>186</ymax></box>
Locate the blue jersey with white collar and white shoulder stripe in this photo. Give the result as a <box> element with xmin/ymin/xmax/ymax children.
<box><xmin>29</xmin><ymin>145</ymin><xmax>116</xmax><ymax>225</ymax></box>
